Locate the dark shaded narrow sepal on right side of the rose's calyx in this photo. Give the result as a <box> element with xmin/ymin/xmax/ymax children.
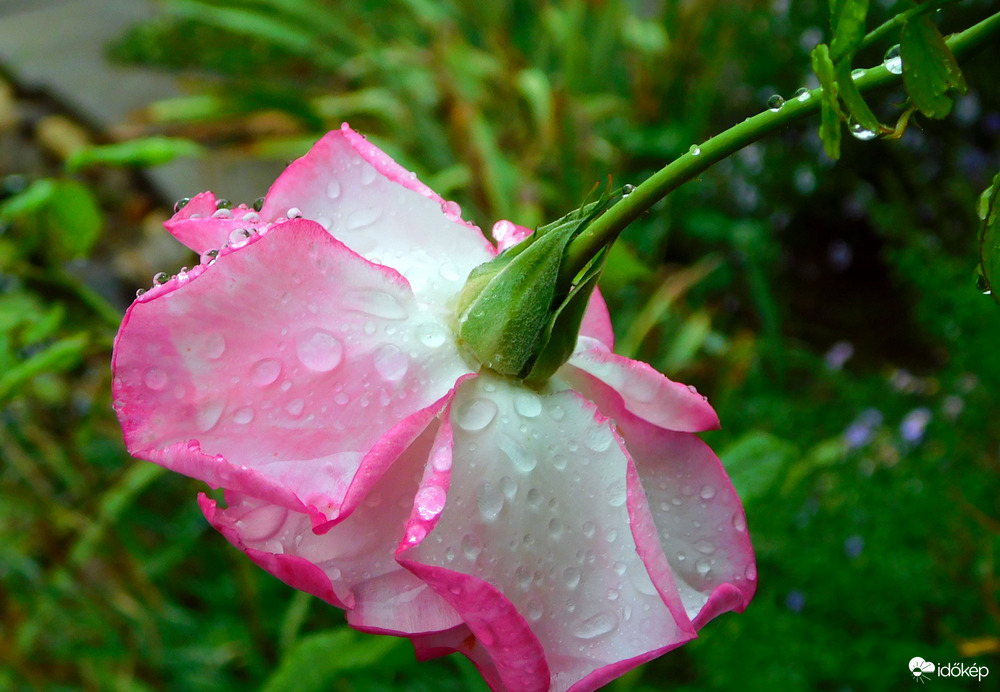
<box><xmin>524</xmin><ymin>248</ymin><xmax>608</xmax><ymax>385</ymax></box>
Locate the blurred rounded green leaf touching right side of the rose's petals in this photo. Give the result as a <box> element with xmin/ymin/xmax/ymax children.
<box><xmin>719</xmin><ymin>431</ymin><xmax>799</xmax><ymax>503</ymax></box>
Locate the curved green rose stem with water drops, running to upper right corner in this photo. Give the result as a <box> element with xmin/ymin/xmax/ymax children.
<box><xmin>559</xmin><ymin>12</ymin><xmax>1000</xmax><ymax>286</ymax></box>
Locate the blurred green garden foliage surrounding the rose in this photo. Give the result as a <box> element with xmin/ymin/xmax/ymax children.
<box><xmin>0</xmin><ymin>0</ymin><xmax>1000</xmax><ymax>692</ymax></box>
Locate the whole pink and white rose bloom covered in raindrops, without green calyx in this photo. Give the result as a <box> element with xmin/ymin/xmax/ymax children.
<box><xmin>113</xmin><ymin>125</ymin><xmax>756</xmax><ymax>692</ymax></box>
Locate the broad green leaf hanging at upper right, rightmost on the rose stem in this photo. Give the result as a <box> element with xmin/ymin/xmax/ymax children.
<box><xmin>899</xmin><ymin>15</ymin><xmax>967</xmax><ymax>118</ymax></box>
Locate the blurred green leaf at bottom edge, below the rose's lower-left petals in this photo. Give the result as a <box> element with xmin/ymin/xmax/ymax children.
<box><xmin>261</xmin><ymin>627</ymin><xmax>403</xmax><ymax>692</ymax></box>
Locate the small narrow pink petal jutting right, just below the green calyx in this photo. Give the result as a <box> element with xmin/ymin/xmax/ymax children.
<box><xmin>558</xmin><ymin>346</ymin><xmax>719</xmax><ymax>432</ymax></box>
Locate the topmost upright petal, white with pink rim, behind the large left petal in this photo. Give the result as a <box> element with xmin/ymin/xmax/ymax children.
<box><xmin>261</xmin><ymin>125</ymin><xmax>496</xmax><ymax>304</ymax></box>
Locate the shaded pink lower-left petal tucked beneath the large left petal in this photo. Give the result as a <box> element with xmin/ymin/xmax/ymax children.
<box><xmin>206</xmin><ymin>416</ymin><xmax>462</xmax><ymax>635</ymax></box>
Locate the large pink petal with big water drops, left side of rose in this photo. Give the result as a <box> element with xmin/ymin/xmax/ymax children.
<box><xmin>113</xmin><ymin>220</ymin><xmax>468</xmax><ymax>521</ymax></box>
